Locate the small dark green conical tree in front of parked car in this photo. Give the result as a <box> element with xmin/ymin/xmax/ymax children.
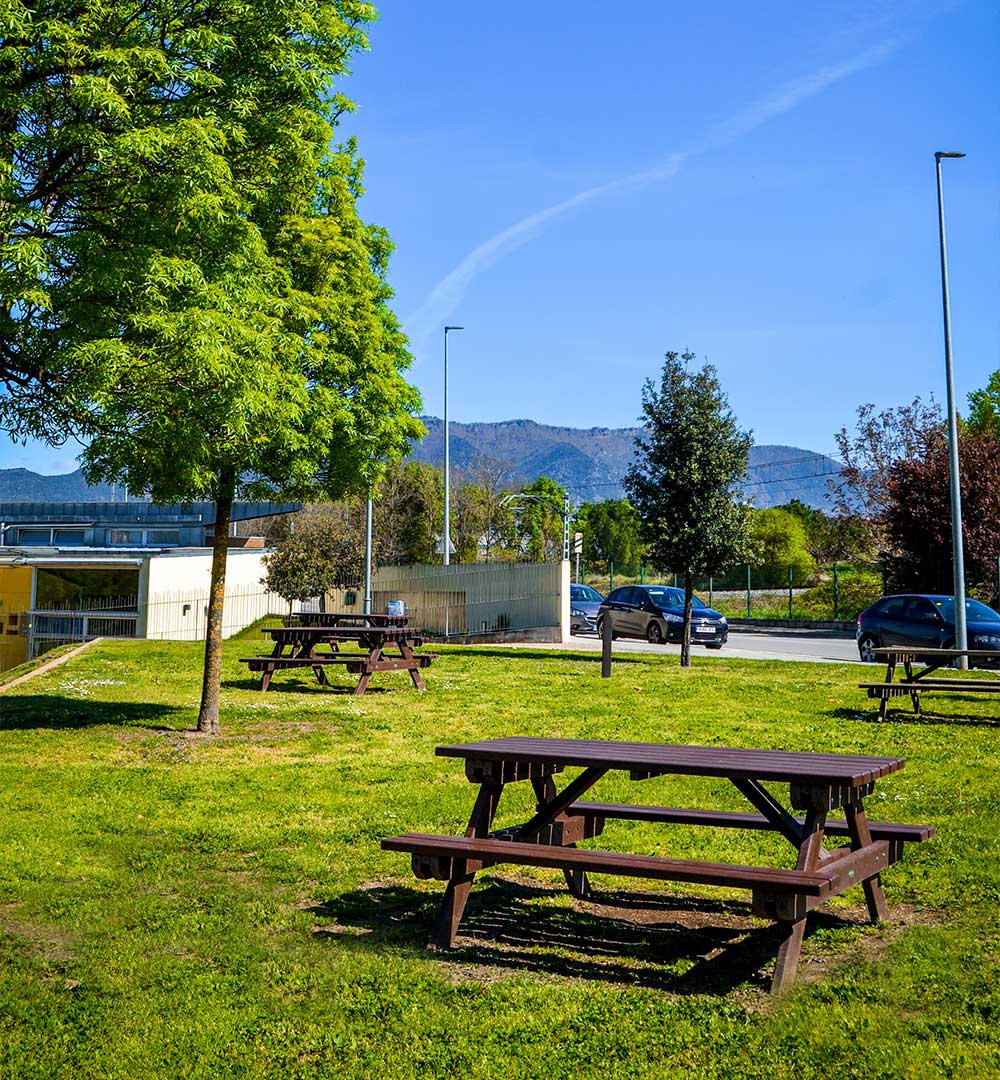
<box><xmin>625</xmin><ymin>352</ymin><xmax>753</xmax><ymax>667</ymax></box>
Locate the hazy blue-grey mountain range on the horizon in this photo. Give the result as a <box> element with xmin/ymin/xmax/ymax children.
<box><xmin>0</xmin><ymin>416</ymin><xmax>841</xmax><ymax>514</ymax></box>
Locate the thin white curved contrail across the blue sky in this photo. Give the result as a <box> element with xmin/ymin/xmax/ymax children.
<box><xmin>403</xmin><ymin>39</ymin><xmax>901</xmax><ymax>349</ymax></box>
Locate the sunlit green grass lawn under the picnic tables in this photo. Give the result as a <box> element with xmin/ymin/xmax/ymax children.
<box><xmin>0</xmin><ymin>643</ymin><xmax>1000</xmax><ymax>1080</ymax></box>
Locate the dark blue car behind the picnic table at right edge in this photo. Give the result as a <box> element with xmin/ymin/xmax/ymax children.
<box><xmin>856</xmin><ymin>593</ymin><xmax>1000</xmax><ymax>667</ymax></box>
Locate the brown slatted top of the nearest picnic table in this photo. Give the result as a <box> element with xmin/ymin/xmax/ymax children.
<box><xmin>435</xmin><ymin>737</ymin><xmax>906</xmax><ymax>787</ymax></box>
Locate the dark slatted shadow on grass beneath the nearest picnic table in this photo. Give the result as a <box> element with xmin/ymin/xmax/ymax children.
<box><xmin>311</xmin><ymin>878</ymin><xmax>854</xmax><ymax>995</ymax></box>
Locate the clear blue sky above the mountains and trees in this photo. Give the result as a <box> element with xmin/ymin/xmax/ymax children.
<box><xmin>0</xmin><ymin>0</ymin><xmax>1000</xmax><ymax>472</ymax></box>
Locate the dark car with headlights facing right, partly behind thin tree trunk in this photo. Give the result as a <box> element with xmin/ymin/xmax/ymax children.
<box><xmin>597</xmin><ymin>585</ymin><xmax>729</xmax><ymax>649</ymax></box>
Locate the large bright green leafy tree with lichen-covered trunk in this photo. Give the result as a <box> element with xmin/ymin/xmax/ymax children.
<box><xmin>0</xmin><ymin>0</ymin><xmax>421</xmax><ymax>731</ymax></box>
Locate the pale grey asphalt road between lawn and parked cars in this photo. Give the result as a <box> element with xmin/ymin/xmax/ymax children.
<box><xmin>563</xmin><ymin>627</ymin><xmax>860</xmax><ymax>664</ymax></box>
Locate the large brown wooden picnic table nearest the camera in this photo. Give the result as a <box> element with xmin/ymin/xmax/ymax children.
<box><xmin>382</xmin><ymin>738</ymin><xmax>934</xmax><ymax>991</ymax></box>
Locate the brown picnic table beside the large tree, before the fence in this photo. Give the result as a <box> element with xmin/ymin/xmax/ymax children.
<box><xmin>240</xmin><ymin>616</ymin><xmax>435</xmax><ymax>698</ymax></box>
